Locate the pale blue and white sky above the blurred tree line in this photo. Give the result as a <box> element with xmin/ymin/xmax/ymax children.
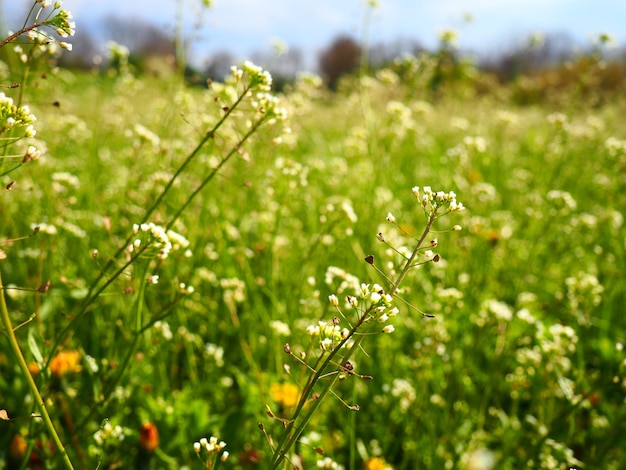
<box><xmin>0</xmin><ymin>0</ymin><xmax>626</xmax><ymax>68</ymax></box>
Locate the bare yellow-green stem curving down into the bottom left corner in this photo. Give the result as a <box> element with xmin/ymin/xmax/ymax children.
<box><xmin>0</xmin><ymin>274</ymin><xmax>74</xmax><ymax>469</ymax></box>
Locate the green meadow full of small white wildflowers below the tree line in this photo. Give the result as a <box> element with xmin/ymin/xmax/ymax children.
<box><xmin>0</xmin><ymin>1</ymin><xmax>626</xmax><ymax>470</ymax></box>
